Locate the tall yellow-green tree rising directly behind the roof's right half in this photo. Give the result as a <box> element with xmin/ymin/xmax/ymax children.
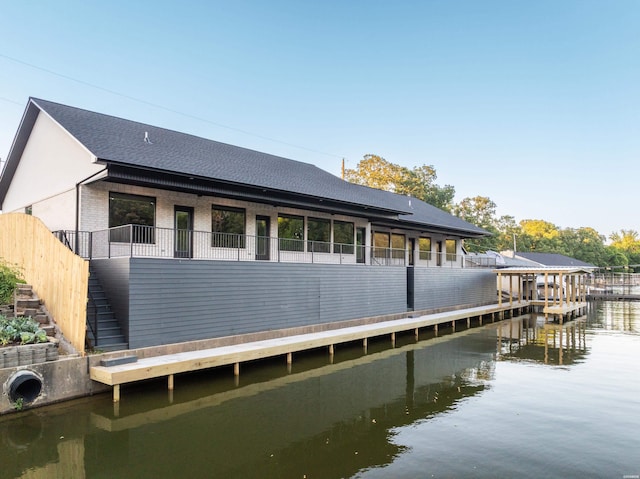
<box><xmin>344</xmin><ymin>154</ymin><xmax>455</xmax><ymax>211</ymax></box>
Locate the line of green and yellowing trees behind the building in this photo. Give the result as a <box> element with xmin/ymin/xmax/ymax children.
<box><xmin>344</xmin><ymin>158</ymin><xmax>640</xmax><ymax>267</ymax></box>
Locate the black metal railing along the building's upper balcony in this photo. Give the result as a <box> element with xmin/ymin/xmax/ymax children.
<box><xmin>54</xmin><ymin>225</ymin><xmax>488</xmax><ymax>268</ymax></box>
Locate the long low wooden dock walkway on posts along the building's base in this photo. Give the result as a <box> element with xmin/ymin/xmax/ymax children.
<box><xmin>90</xmin><ymin>301</ymin><xmax>530</xmax><ymax>402</ymax></box>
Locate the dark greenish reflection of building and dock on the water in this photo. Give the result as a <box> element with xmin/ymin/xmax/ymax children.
<box><xmin>0</xmin><ymin>315</ymin><xmax>587</xmax><ymax>478</ymax></box>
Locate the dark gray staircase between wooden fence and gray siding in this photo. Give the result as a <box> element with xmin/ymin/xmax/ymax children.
<box><xmin>87</xmin><ymin>263</ymin><xmax>129</xmax><ymax>351</ymax></box>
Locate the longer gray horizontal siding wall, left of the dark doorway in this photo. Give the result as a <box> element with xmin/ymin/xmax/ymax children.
<box><xmin>128</xmin><ymin>258</ymin><xmax>407</xmax><ymax>348</ymax></box>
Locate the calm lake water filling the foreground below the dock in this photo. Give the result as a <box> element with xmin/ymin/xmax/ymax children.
<box><xmin>0</xmin><ymin>302</ymin><xmax>640</xmax><ymax>479</ymax></box>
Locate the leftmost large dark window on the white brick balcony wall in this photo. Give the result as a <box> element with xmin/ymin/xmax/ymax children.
<box><xmin>109</xmin><ymin>193</ymin><xmax>156</xmax><ymax>244</ymax></box>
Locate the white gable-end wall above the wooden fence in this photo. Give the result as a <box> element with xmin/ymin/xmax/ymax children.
<box><xmin>3</xmin><ymin>112</ymin><xmax>104</xmax><ymax>230</ymax></box>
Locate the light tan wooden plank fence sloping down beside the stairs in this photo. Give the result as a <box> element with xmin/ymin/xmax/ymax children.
<box><xmin>0</xmin><ymin>213</ymin><xmax>89</xmax><ymax>353</ymax></box>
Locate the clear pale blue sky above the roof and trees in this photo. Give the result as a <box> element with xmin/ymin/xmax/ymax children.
<box><xmin>0</xmin><ymin>0</ymin><xmax>640</xmax><ymax>236</ymax></box>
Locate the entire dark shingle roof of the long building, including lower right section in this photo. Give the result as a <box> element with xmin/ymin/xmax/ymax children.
<box><xmin>0</xmin><ymin>98</ymin><xmax>487</xmax><ymax>236</ymax></box>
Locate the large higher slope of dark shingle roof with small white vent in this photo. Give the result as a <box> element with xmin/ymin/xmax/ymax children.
<box><xmin>33</xmin><ymin>99</ymin><xmax>416</xmax><ymax>212</ymax></box>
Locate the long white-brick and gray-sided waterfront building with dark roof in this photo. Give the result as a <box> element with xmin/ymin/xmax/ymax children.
<box><xmin>0</xmin><ymin>98</ymin><xmax>496</xmax><ymax>350</ymax></box>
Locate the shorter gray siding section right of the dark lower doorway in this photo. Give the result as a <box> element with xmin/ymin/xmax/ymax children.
<box><xmin>409</xmin><ymin>267</ymin><xmax>497</xmax><ymax>311</ymax></box>
